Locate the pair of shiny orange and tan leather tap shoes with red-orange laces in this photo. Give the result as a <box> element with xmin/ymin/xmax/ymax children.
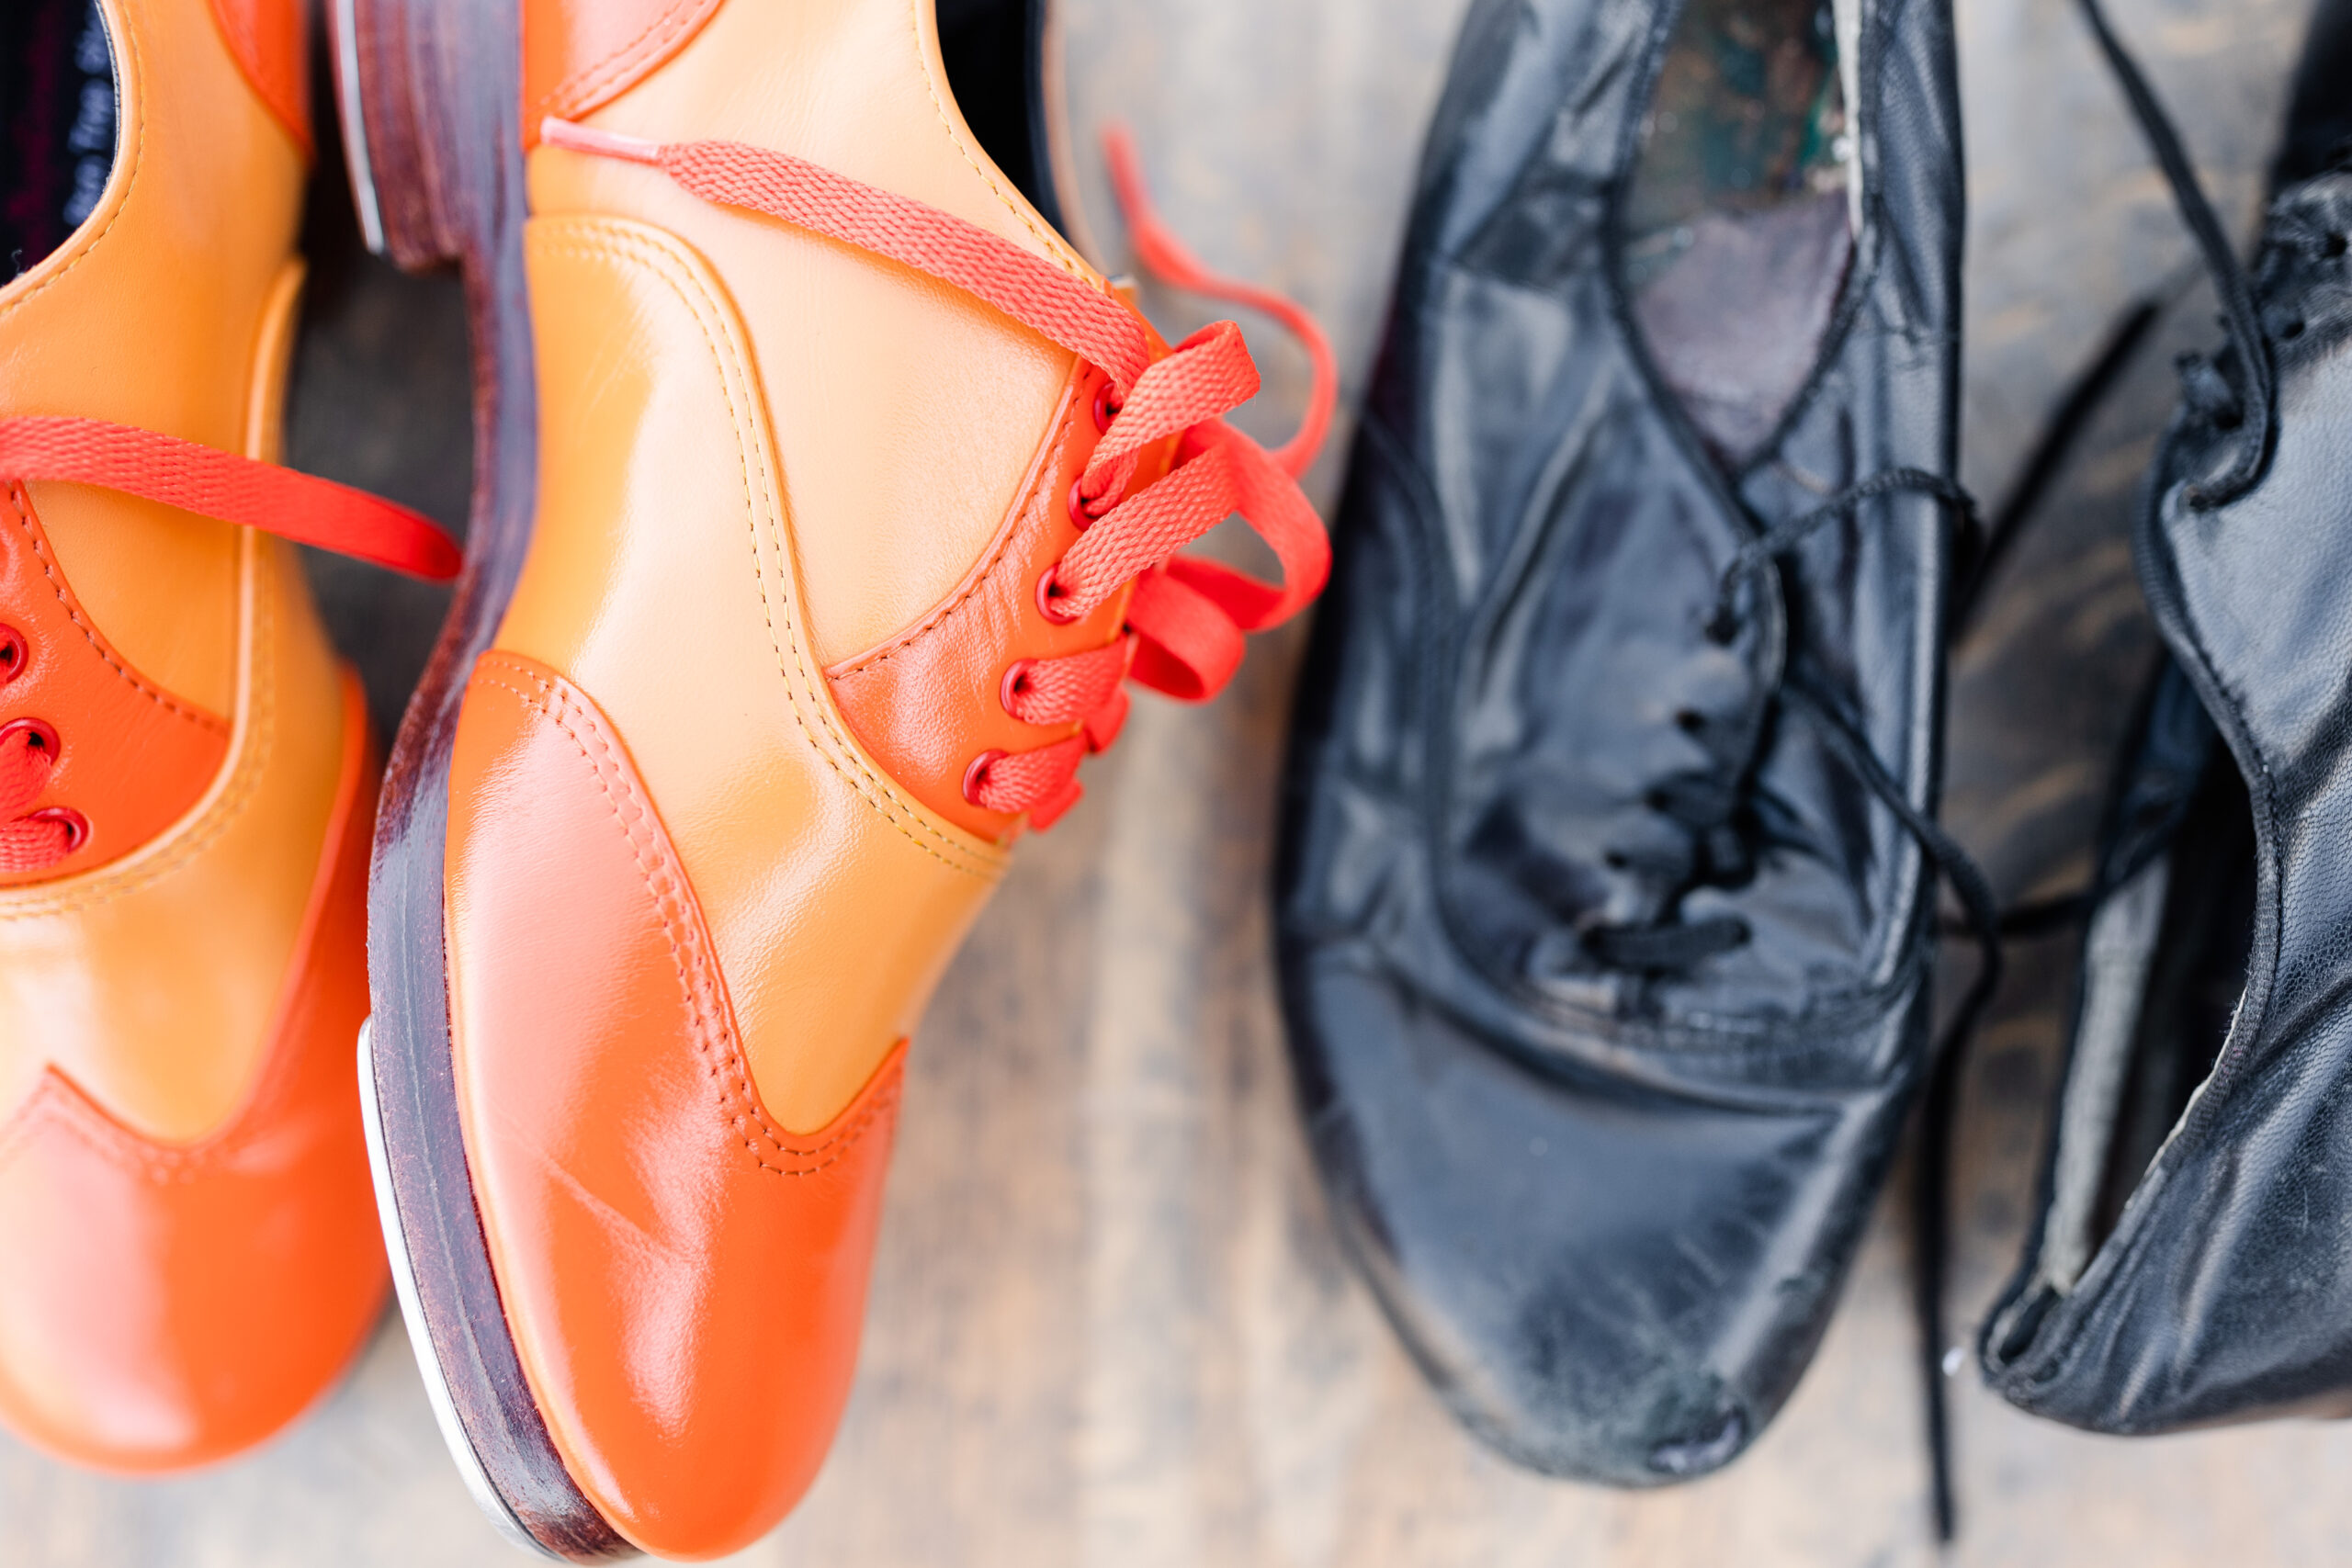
<box><xmin>0</xmin><ymin>0</ymin><xmax>1329</xmax><ymax>1559</ymax></box>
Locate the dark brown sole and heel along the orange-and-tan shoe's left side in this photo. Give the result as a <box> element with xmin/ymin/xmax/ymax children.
<box><xmin>327</xmin><ymin>0</ymin><xmax>635</xmax><ymax>1563</ymax></box>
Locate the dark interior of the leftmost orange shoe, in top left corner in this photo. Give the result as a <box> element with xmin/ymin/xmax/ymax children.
<box><xmin>0</xmin><ymin>0</ymin><xmax>118</xmax><ymax>277</ymax></box>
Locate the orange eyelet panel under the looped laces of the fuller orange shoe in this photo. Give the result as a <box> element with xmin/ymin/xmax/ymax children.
<box><xmin>826</xmin><ymin>367</ymin><xmax>1138</xmax><ymax>840</ymax></box>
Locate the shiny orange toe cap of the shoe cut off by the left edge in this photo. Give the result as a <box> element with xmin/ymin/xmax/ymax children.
<box><xmin>0</xmin><ymin>682</ymin><xmax>386</xmax><ymax>1472</ymax></box>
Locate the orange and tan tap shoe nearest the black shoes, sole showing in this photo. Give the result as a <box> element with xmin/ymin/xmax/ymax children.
<box><xmin>336</xmin><ymin>0</ymin><xmax>1331</xmax><ymax>1561</ymax></box>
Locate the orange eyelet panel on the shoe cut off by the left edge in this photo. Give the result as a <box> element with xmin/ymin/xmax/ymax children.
<box><xmin>0</xmin><ymin>484</ymin><xmax>228</xmax><ymax>886</ymax></box>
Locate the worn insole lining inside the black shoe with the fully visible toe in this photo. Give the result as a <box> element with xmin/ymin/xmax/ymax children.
<box><xmin>1623</xmin><ymin>0</ymin><xmax>1860</xmax><ymax>468</ymax></box>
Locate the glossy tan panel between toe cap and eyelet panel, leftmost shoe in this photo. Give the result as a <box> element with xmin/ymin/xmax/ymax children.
<box><xmin>0</xmin><ymin>534</ymin><xmax>348</xmax><ymax>1143</ymax></box>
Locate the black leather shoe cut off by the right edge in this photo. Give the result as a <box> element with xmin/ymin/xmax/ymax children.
<box><xmin>1981</xmin><ymin>0</ymin><xmax>2352</xmax><ymax>1434</ymax></box>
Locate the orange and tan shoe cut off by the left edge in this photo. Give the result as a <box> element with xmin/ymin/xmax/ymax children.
<box><xmin>0</xmin><ymin>0</ymin><xmax>457</xmax><ymax>1472</ymax></box>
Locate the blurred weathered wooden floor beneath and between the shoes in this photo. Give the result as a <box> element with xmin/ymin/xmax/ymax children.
<box><xmin>0</xmin><ymin>0</ymin><xmax>2352</xmax><ymax>1568</ymax></box>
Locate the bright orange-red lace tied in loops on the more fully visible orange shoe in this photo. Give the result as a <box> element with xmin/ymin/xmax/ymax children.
<box><xmin>538</xmin><ymin>118</ymin><xmax>1339</xmax><ymax>829</ymax></box>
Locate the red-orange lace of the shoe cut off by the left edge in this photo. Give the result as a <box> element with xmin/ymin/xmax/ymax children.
<box><xmin>0</xmin><ymin>416</ymin><xmax>458</xmax><ymax>874</ymax></box>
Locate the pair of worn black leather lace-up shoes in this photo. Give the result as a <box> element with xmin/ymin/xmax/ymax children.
<box><xmin>1277</xmin><ymin>0</ymin><xmax>2352</xmax><ymax>1485</ymax></box>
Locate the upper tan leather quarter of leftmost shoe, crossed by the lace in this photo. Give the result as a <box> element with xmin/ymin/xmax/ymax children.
<box><xmin>0</xmin><ymin>0</ymin><xmax>303</xmax><ymax>712</ymax></box>
